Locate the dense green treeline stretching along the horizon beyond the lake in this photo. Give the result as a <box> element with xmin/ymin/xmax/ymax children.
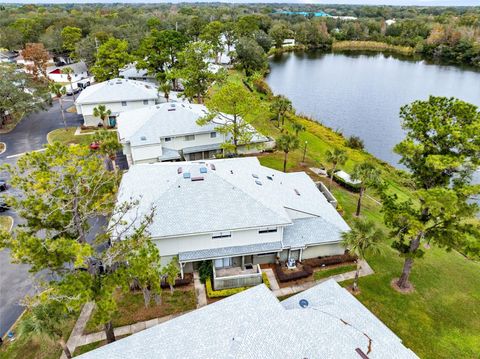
<box><xmin>0</xmin><ymin>4</ymin><xmax>480</xmax><ymax>67</ymax></box>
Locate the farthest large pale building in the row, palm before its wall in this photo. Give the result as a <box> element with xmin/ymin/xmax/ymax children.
<box><xmin>75</xmin><ymin>78</ymin><xmax>158</xmax><ymax>126</ymax></box>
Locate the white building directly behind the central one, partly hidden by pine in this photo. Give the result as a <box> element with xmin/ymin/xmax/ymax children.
<box><xmin>117</xmin><ymin>102</ymin><xmax>270</xmax><ymax>165</ymax></box>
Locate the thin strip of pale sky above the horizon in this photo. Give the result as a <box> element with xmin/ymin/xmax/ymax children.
<box><xmin>0</xmin><ymin>0</ymin><xmax>480</xmax><ymax>6</ymax></box>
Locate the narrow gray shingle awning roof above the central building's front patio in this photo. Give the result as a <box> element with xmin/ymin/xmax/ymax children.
<box><xmin>178</xmin><ymin>242</ymin><xmax>282</xmax><ymax>262</ymax></box>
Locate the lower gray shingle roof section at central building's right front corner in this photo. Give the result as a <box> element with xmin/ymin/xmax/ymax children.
<box><xmin>283</xmin><ymin>217</ymin><xmax>342</xmax><ymax>248</ymax></box>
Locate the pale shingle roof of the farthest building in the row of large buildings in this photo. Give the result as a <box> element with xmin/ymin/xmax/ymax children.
<box><xmin>76</xmin><ymin>78</ymin><xmax>158</xmax><ymax>105</ymax></box>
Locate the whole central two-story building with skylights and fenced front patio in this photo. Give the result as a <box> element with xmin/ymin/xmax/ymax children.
<box><xmin>117</xmin><ymin>157</ymin><xmax>349</xmax><ymax>288</ymax></box>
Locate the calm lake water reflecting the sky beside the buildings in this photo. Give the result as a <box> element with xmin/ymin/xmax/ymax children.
<box><xmin>267</xmin><ymin>52</ymin><xmax>480</xmax><ymax>191</ymax></box>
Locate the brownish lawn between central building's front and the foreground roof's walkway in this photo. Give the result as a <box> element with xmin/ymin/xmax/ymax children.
<box><xmin>85</xmin><ymin>288</ymin><xmax>197</xmax><ymax>333</ymax></box>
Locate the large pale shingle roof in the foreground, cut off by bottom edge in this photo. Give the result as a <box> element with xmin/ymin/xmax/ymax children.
<box><xmin>78</xmin><ymin>280</ymin><xmax>418</xmax><ymax>359</ymax></box>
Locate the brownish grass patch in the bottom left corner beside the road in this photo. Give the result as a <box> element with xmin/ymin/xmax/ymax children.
<box><xmin>0</xmin><ymin>313</ymin><xmax>77</xmax><ymax>359</ymax></box>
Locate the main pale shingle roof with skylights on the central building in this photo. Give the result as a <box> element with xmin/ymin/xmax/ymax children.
<box><xmin>114</xmin><ymin>157</ymin><xmax>349</xmax><ymax>238</ymax></box>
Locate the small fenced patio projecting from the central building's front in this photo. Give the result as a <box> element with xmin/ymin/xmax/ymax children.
<box><xmin>213</xmin><ymin>264</ymin><xmax>262</xmax><ymax>290</ymax></box>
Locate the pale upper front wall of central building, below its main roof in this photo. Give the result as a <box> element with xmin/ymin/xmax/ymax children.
<box><xmin>154</xmin><ymin>228</ymin><xmax>282</xmax><ymax>256</ymax></box>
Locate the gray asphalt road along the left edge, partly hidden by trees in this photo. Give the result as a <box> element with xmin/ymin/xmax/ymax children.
<box><xmin>0</xmin><ymin>97</ymin><xmax>82</xmax><ymax>336</ymax></box>
